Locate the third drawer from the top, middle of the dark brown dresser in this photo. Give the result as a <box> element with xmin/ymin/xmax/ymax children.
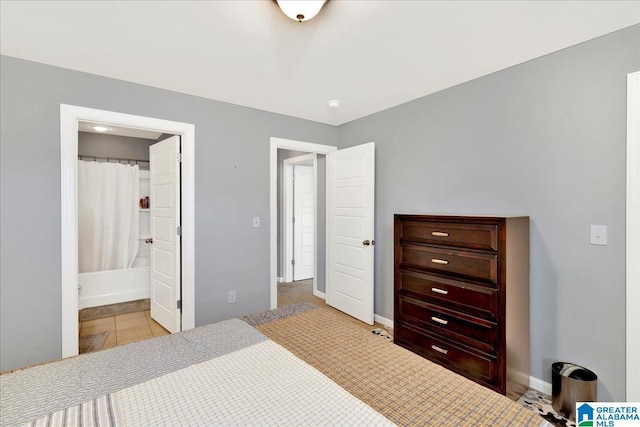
<box><xmin>396</xmin><ymin>270</ymin><xmax>498</xmax><ymax>319</ymax></box>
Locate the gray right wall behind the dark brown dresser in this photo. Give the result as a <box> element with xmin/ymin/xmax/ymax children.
<box><xmin>338</xmin><ymin>25</ymin><xmax>640</xmax><ymax>401</ymax></box>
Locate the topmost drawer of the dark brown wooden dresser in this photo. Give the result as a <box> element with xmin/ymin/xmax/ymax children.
<box><xmin>400</xmin><ymin>221</ymin><xmax>498</xmax><ymax>251</ymax></box>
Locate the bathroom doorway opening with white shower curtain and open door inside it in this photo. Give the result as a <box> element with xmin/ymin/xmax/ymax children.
<box><xmin>77</xmin><ymin>122</ymin><xmax>180</xmax><ymax>354</ymax></box>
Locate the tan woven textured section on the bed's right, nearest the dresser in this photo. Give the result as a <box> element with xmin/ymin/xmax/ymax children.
<box><xmin>256</xmin><ymin>307</ymin><xmax>544</xmax><ymax>427</ymax></box>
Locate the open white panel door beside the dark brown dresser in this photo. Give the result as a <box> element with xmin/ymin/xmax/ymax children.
<box><xmin>326</xmin><ymin>142</ymin><xmax>375</xmax><ymax>325</ymax></box>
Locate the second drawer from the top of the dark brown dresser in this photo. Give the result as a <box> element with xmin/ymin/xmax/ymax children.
<box><xmin>400</xmin><ymin>245</ymin><xmax>498</xmax><ymax>286</ymax></box>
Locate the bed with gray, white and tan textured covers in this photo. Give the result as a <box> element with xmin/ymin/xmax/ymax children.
<box><xmin>0</xmin><ymin>303</ymin><xmax>543</xmax><ymax>426</ymax></box>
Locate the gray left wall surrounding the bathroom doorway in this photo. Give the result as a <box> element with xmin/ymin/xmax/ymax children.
<box><xmin>0</xmin><ymin>56</ymin><xmax>337</xmax><ymax>371</ymax></box>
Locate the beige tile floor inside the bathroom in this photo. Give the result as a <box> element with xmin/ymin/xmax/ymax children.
<box><xmin>80</xmin><ymin>310</ymin><xmax>169</xmax><ymax>350</ymax></box>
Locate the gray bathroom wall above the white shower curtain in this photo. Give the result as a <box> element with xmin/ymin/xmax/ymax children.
<box><xmin>78</xmin><ymin>132</ymin><xmax>156</xmax><ymax>164</ymax></box>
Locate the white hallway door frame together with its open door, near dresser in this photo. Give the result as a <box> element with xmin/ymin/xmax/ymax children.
<box><xmin>269</xmin><ymin>137</ymin><xmax>375</xmax><ymax>325</ymax></box>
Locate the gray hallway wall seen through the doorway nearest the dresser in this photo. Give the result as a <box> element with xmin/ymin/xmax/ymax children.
<box><xmin>277</xmin><ymin>149</ymin><xmax>327</xmax><ymax>292</ymax></box>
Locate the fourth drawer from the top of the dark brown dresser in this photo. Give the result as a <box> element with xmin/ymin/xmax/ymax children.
<box><xmin>399</xmin><ymin>296</ymin><xmax>498</xmax><ymax>352</ymax></box>
